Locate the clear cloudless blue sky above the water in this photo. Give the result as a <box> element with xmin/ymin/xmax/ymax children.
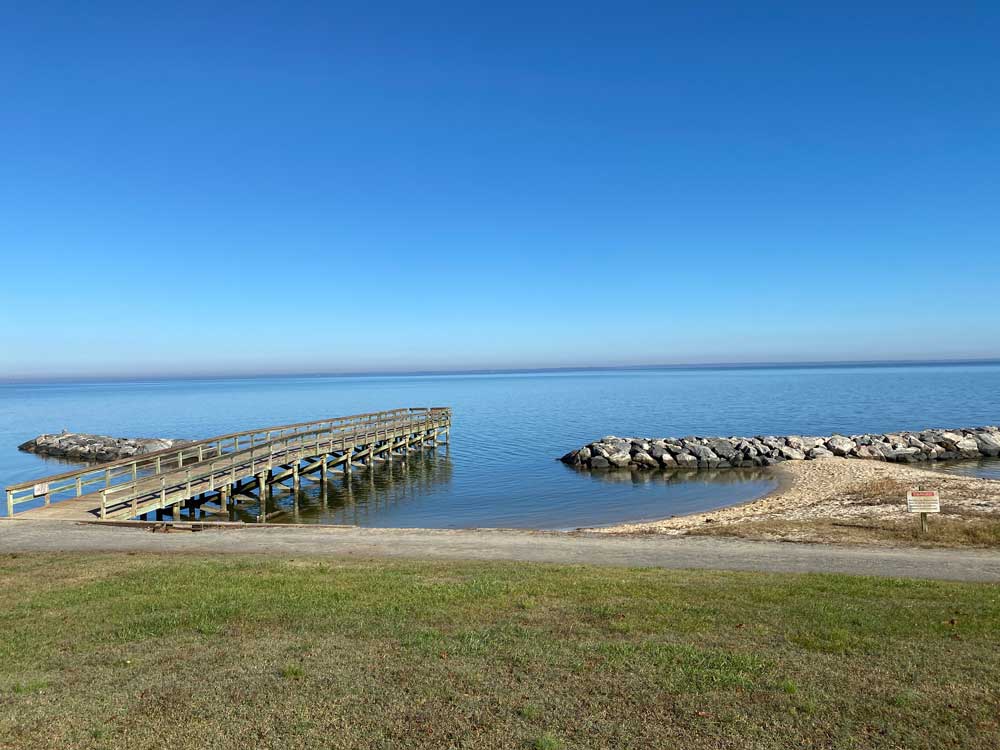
<box><xmin>0</xmin><ymin>0</ymin><xmax>1000</xmax><ymax>377</ymax></box>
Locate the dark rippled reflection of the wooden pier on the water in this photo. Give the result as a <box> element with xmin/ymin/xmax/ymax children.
<box><xmin>252</xmin><ymin>451</ymin><xmax>452</xmax><ymax>525</ymax></box>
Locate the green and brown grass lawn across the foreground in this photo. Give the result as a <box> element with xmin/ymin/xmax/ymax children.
<box><xmin>0</xmin><ymin>555</ymin><xmax>1000</xmax><ymax>749</ymax></box>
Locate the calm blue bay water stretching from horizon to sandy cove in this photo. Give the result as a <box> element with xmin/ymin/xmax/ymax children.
<box><xmin>0</xmin><ymin>364</ymin><xmax>1000</xmax><ymax>528</ymax></box>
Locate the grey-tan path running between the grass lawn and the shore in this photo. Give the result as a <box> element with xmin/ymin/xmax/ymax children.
<box><xmin>0</xmin><ymin>520</ymin><xmax>1000</xmax><ymax>582</ymax></box>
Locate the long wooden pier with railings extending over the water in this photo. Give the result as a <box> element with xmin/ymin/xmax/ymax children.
<box><xmin>7</xmin><ymin>407</ymin><xmax>451</xmax><ymax>521</ymax></box>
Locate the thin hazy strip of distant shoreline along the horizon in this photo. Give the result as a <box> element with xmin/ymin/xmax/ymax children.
<box><xmin>0</xmin><ymin>358</ymin><xmax>1000</xmax><ymax>387</ymax></box>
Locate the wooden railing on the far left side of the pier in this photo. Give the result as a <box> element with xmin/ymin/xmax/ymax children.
<box><xmin>6</xmin><ymin>407</ymin><xmax>450</xmax><ymax>513</ymax></box>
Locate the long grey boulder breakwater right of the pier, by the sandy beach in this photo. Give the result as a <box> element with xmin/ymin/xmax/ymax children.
<box><xmin>560</xmin><ymin>426</ymin><xmax>1000</xmax><ymax>469</ymax></box>
